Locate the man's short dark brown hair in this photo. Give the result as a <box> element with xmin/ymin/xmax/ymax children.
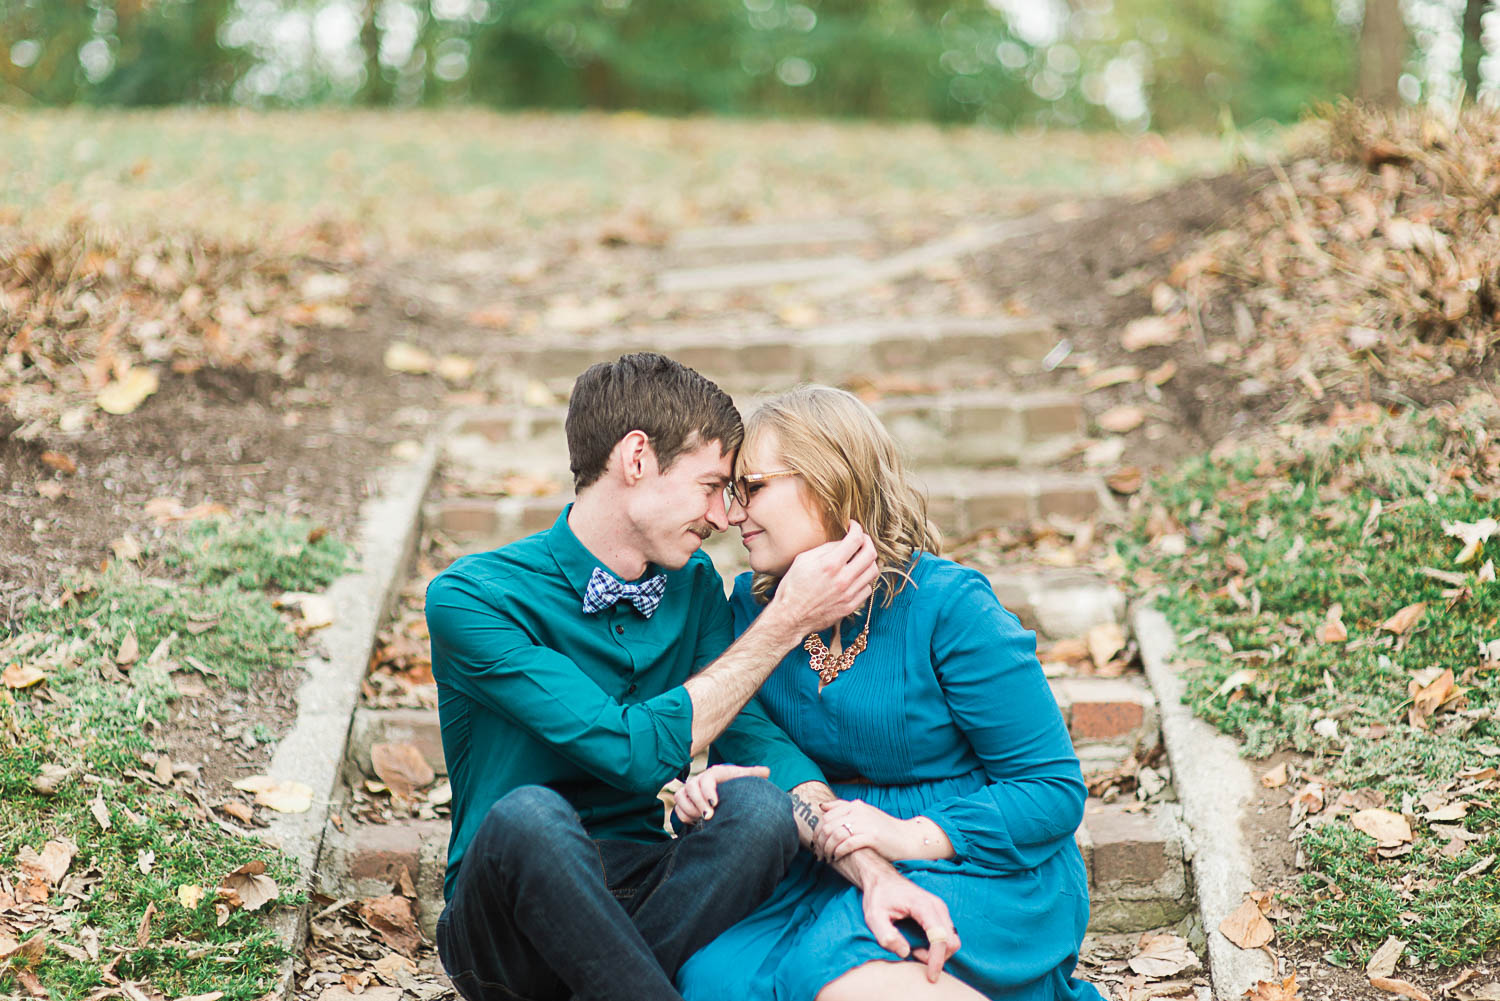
<box><xmin>566</xmin><ymin>351</ymin><xmax>744</xmax><ymax>491</ymax></box>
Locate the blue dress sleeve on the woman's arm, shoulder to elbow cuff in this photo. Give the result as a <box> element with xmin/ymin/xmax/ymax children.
<box><xmin>926</xmin><ymin>573</ymin><xmax>1088</xmax><ymax>872</ymax></box>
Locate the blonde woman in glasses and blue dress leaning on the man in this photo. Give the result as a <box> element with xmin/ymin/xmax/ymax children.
<box><xmin>678</xmin><ymin>386</ymin><xmax>1100</xmax><ymax>1001</ymax></box>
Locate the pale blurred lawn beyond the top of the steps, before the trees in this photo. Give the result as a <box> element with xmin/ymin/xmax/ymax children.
<box><xmin>0</xmin><ymin>108</ymin><xmax>1260</xmax><ymax>249</ymax></box>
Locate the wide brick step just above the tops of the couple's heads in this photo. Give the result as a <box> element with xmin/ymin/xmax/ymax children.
<box><xmin>486</xmin><ymin>317</ymin><xmax>1059</xmax><ymax>398</ymax></box>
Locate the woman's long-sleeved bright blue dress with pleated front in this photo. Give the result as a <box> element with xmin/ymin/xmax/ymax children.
<box><xmin>678</xmin><ymin>554</ymin><xmax>1101</xmax><ymax>1001</ymax></box>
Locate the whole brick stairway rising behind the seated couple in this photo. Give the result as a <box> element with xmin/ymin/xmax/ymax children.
<box><xmin>304</xmin><ymin>224</ymin><xmax>1193</xmax><ymax>996</ymax></box>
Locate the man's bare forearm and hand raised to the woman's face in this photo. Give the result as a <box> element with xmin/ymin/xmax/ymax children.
<box><xmin>683</xmin><ymin>524</ymin><xmax>879</xmax><ymax>750</ymax></box>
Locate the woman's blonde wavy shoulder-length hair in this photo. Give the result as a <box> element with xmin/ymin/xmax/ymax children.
<box><xmin>735</xmin><ymin>386</ymin><xmax>942</xmax><ymax>606</ymax></box>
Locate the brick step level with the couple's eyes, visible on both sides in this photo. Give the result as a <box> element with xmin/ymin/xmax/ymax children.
<box><xmin>423</xmin><ymin>468</ymin><xmax>1115</xmax><ymax>548</ymax></box>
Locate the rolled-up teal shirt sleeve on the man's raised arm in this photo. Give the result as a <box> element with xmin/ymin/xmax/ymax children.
<box><xmin>428</xmin><ymin>573</ymin><xmax>693</xmax><ymax>795</ymax></box>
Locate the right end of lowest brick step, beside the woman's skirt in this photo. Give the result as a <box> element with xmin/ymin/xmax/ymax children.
<box><xmin>1074</xmin><ymin>798</ymin><xmax>1194</xmax><ymax>933</ymax></box>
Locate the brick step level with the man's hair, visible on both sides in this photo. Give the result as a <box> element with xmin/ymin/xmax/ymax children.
<box><xmin>444</xmin><ymin>389</ymin><xmax>1086</xmax><ymax>483</ymax></box>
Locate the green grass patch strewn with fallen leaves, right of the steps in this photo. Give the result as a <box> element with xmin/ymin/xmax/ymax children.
<box><xmin>1121</xmin><ymin>401</ymin><xmax>1500</xmax><ymax>965</ymax></box>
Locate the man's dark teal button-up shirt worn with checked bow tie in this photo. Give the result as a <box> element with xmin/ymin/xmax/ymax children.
<box><xmin>428</xmin><ymin>506</ymin><xmax>824</xmax><ymax>896</ymax></box>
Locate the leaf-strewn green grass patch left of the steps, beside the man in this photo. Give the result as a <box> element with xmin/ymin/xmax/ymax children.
<box><xmin>0</xmin><ymin>518</ymin><xmax>347</xmax><ymax>1001</ymax></box>
